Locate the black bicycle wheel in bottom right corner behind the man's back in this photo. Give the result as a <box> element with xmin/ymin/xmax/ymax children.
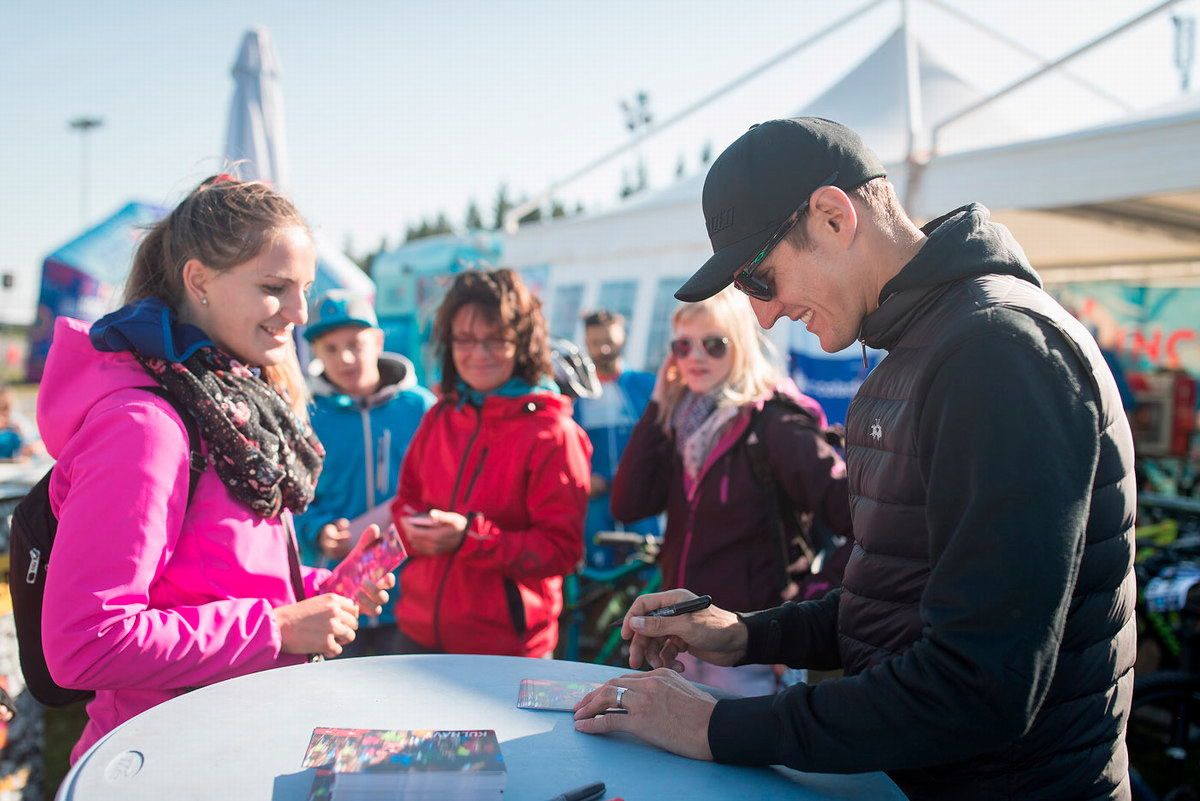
<box><xmin>1126</xmin><ymin>670</ymin><xmax>1200</xmax><ymax>799</ymax></box>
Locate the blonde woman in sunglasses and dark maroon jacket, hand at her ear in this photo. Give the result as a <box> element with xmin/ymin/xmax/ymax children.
<box><xmin>612</xmin><ymin>287</ymin><xmax>852</xmax><ymax>695</ymax></box>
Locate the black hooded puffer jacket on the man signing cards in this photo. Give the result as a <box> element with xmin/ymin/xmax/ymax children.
<box><xmin>709</xmin><ymin>206</ymin><xmax>1136</xmax><ymax>799</ymax></box>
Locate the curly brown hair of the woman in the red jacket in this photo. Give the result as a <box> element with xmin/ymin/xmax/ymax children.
<box><xmin>432</xmin><ymin>269</ymin><xmax>551</xmax><ymax>395</ymax></box>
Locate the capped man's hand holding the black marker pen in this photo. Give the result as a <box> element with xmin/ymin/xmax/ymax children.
<box><xmin>620</xmin><ymin>590</ymin><xmax>749</xmax><ymax>670</ymax></box>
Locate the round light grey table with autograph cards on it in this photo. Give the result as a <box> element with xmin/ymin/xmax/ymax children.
<box><xmin>56</xmin><ymin>655</ymin><xmax>904</xmax><ymax>801</ymax></box>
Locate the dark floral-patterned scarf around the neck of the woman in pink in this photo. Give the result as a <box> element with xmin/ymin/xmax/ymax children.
<box><xmin>132</xmin><ymin>344</ymin><xmax>325</xmax><ymax>518</ymax></box>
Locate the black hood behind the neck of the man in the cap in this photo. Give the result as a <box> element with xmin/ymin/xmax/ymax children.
<box><xmin>860</xmin><ymin>203</ymin><xmax>1042</xmax><ymax>349</ymax></box>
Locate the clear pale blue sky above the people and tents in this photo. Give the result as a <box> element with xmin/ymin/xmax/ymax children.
<box><xmin>0</xmin><ymin>0</ymin><xmax>1198</xmax><ymax>321</ymax></box>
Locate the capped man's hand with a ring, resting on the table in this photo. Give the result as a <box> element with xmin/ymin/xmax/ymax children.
<box><xmin>575</xmin><ymin>670</ymin><xmax>716</xmax><ymax>760</ymax></box>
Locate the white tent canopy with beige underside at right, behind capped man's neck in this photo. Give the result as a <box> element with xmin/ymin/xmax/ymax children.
<box><xmin>901</xmin><ymin>95</ymin><xmax>1200</xmax><ymax>282</ymax></box>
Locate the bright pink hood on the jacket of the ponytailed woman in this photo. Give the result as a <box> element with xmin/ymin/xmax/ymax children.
<box><xmin>37</xmin><ymin>317</ymin><xmax>159</xmax><ymax>458</ymax></box>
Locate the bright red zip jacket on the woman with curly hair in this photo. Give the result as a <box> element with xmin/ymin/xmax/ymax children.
<box><xmin>391</xmin><ymin>393</ymin><xmax>592</xmax><ymax>657</ymax></box>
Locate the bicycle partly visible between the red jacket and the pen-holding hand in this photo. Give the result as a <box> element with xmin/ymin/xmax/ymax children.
<box><xmin>557</xmin><ymin>531</ymin><xmax>662</xmax><ymax>667</ymax></box>
